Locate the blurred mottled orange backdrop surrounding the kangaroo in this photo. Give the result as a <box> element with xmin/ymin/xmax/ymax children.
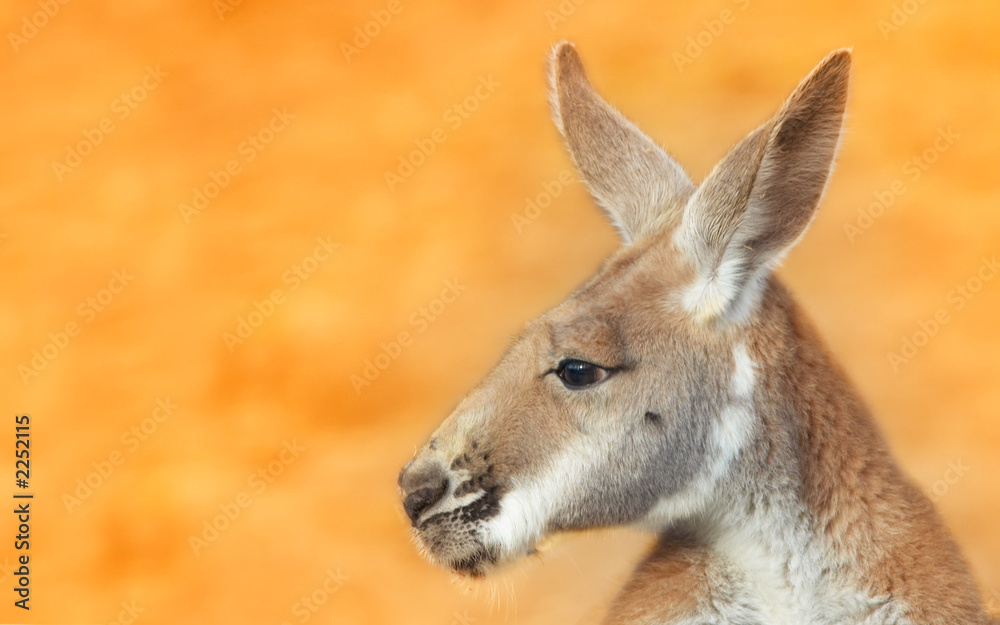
<box><xmin>0</xmin><ymin>0</ymin><xmax>1000</xmax><ymax>625</ymax></box>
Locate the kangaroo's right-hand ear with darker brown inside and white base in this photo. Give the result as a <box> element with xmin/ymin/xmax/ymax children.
<box><xmin>674</xmin><ymin>49</ymin><xmax>851</xmax><ymax>321</ymax></box>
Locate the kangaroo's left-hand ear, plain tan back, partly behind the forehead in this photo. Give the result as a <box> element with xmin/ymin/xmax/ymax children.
<box><xmin>549</xmin><ymin>42</ymin><xmax>695</xmax><ymax>244</ymax></box>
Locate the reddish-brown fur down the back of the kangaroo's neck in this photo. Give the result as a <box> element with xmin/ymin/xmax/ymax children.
<box><xmin>751</xmin><ymin>283</ymin><xmax>987</xmax><ymax>623</ymax></box>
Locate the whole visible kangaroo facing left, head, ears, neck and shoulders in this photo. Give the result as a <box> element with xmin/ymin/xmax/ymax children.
<box><xmin>399</xmin><ymin>43</ymin><xmax>992</xmax><ymax>625</ymax></box>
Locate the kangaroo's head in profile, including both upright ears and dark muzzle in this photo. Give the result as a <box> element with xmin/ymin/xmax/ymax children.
<box><xmin>399</xmin><ymin>43</ymin><xmax>850</xmax><ymax>575</ymax></box>
